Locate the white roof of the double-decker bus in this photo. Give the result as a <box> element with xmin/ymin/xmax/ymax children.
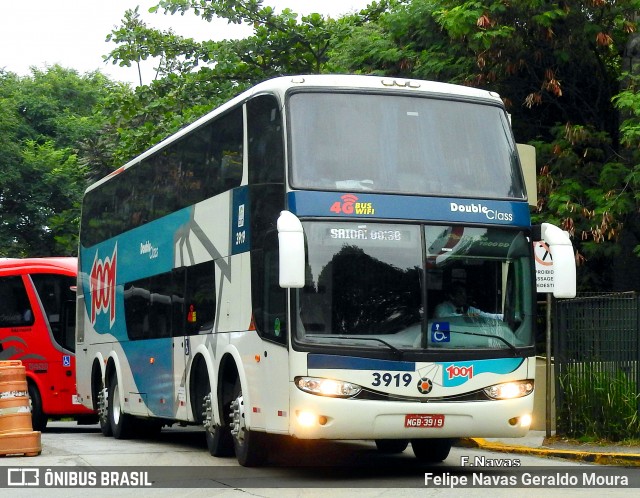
<box><xmin>85</xmin><ymin>74</ymin><xmax>503</xmax><ymax>193</ymax></box>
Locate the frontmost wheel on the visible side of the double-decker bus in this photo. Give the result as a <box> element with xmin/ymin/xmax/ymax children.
<box><xmin>231</xmin><ymin>379</ymin><xmax>268</xmax><ymax>467</ymax></box>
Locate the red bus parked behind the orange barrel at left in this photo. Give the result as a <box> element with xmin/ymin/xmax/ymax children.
<box><xmin>0</xmin><ymin>257</ymin><xmax>97</xmax><ymax>431</ymax></box>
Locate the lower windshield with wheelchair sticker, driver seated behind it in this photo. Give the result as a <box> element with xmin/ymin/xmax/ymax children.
<box><xmin>296</xmin><ymin>222</ymin><xmax>534</xmax><ymax>350</ymax></box>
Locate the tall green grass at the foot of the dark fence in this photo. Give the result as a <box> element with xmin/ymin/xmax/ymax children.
<box><xmin>556</xmin><ymin>363</ymin><xmax>640</xmax><ymax>441</ymax></box>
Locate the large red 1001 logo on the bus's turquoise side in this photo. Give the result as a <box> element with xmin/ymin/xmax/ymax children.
<box><xmin>89</xmin><ymin>244</ymin><xmax>118</xmax><ymax>327</ymax></box>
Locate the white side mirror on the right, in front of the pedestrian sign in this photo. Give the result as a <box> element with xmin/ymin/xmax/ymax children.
<box><xmin>540</xmin><ymin>223</ymin><xmax>576</xmax><ymax>298</ymax></box>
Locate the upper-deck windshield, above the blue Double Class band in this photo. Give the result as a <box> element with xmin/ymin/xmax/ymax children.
<box><xmin>289</xmin><ymin>92</ymin><xmax>525</xmax><ymax>200</ymax></box>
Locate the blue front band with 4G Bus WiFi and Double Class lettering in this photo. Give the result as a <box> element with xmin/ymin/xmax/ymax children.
<box><xmin>288</xmin><ymin>191</ymin><xmax>531</xmax><ymax>227</ymax></box>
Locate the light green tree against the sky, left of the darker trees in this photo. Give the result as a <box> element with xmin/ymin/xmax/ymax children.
<box><xmin>106</xmin><ymin>0</ymin><xmax>388</xmax><ymax>164</ymax></box>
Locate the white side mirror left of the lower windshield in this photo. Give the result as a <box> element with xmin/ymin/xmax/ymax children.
<box><xmin>278</xmin><ymin>211</ymin><xmax>305</xmax><ymax>289</ymax></box>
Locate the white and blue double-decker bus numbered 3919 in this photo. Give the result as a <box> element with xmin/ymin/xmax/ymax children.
<box><xmin>76</xmin><ymin>75</ymin><xmax>575</xmax><ymax>466</ymax></box>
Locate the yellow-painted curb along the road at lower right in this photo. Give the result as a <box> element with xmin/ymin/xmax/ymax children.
<box><xmin>457</xmin><ymin>438</ymin><xmax>640</xmax><ymax>467</ymax></box>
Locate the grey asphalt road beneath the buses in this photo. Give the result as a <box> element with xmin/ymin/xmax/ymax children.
<box><xmin>0</xmin><ymin>422</ymin><xmax>629</xmax><ymax>498</ymax></box>
